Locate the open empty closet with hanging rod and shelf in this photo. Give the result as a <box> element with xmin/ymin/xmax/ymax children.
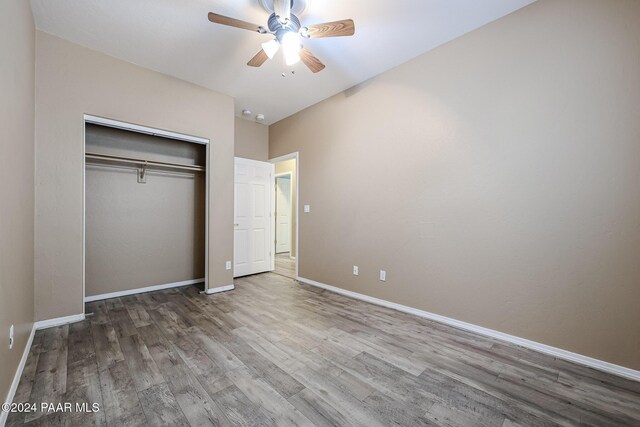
<box><xmin>85</xmin><ymin>123</ymin><xmax>207</xmax><ymax>301</ymax></box>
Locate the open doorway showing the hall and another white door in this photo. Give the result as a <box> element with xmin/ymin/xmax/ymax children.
<box><xmin>271</xmin><ymin>153</ymin><xmax>298</xmax><ymax>279</ymax></box>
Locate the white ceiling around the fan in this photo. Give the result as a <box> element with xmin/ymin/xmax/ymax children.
<box><xmin>31</xmin><ymin>0</ymin><xmax>535</xmax><ymax>124</ymax></box>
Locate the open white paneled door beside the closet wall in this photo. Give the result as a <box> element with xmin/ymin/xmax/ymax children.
<box><xmin>233</xmin><ymin>157</ymin><xmax>274</xmax><ymax>277</ymax></box>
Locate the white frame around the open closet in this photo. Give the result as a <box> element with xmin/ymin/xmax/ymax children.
<box><xmin>82</xmin><ymin>114</ymin><xmax>212</xmax><ymax>308</ymax></box>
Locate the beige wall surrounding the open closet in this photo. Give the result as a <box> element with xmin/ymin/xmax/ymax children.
<box><xmin>35</xmin><ymin>32</ymin><xmax>234</xmax><ymax>320</ymax></box>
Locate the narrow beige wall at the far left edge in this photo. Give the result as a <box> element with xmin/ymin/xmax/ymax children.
<box><xmin>0</xmin><ymin>0</ymin><xmax>35</xmax><ymax>402</ymax></box>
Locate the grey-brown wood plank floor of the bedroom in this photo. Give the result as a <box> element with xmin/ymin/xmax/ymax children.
<box><xmin>8</xmin><ymin>274</ymin><xmax>640</xmax><ymax>427</ymax></box>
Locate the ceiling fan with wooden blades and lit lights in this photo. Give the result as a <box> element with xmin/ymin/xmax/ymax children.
<box><xmin>209</xmin><ymin>0</ymin><xmax>355</xmax><ymax>73</ymax></box>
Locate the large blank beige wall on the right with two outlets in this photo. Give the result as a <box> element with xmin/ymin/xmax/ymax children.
<box><xmin>270</xmin><ymin>0</ymin><xmax>640</xmax><ymax>369</ymax></box>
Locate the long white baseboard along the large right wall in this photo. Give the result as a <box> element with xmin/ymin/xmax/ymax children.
<box><xmin>297</xmin><ymin>277</ymin><xmax>640</xmax><ymax>381</ymax></box>
